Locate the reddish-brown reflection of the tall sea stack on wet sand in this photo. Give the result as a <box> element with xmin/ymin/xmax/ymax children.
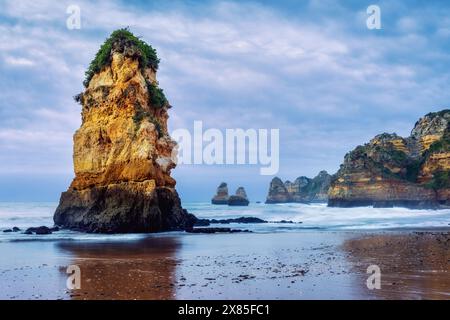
<box><xmin>57</xmin><ymin>236</ymin><xmax>180</xmax><ymax>300</ymax></box>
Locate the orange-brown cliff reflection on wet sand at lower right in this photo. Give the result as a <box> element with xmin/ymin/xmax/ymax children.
<box><xmin>344</xmin><ymin>232</ymin><xmax>450</xmax><ymax>300</ymax></box>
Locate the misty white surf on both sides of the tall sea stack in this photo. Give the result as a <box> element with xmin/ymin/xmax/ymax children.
<box><xmin>0</xmin><ymin>202</ymin><xmax>450</xmax><ymax>241</ymax></box>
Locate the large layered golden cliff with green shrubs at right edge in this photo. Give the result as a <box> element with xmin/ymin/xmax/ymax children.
<box><xmin>328</xmin><ymin>110</ymin><xmax>450</xmax><ymax>208</ymax></box>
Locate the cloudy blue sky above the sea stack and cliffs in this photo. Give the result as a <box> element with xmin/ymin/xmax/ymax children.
<box><xmin>0</xmin><ymin>0</ymin><xmax>450</xmax><ymax>202</ymax></box>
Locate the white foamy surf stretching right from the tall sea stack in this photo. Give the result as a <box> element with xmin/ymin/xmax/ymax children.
<box><xmin>185</xmin><ymin>203</ymin><xmax>450</xmax><ymax>230</ymax></box>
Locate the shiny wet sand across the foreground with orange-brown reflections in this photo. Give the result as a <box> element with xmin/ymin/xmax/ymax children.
<box><xmin>0</xmin><ymin>230</ymin><xmax>450</xmax><ymax>299</ymax></box>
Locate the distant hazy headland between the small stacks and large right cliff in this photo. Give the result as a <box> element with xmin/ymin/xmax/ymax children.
<box><xmin>266</xmin><ymin>171</ymin><xmax>331</xmax><ymax>203</ymax></box>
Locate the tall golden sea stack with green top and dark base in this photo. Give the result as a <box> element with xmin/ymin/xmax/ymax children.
<box><xmin>54</xmin><ymin>29</ymin><xmax>195</xmax><ymax>233</ymax></box>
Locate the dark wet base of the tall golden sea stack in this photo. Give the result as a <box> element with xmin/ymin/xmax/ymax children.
<box><xmin>53</xmin><ymin>184</ymin><xmax>195</xmax><ymax>233</ymax></box>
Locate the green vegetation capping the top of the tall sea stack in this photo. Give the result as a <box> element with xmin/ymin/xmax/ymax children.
<box><xmin>83</xmin><ymin>28</ymin><xmax>159</xmax><ymax>87</ymax></box>
